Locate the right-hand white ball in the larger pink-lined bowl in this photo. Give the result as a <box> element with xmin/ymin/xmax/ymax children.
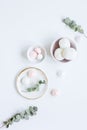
<box><xmin>62</xmin><ymin>48</ymin><xmax>77</xmax><ymax>60</ymax></box>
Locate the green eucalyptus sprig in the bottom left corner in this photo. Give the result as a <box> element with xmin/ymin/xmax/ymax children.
<box><xmin>3</xmin><ymin>106</ymin><xmax>38</xmax><ymax>128</ymax></box>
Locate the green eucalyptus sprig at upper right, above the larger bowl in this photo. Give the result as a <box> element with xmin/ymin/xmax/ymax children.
<box><xmin>62</xmin><ymin>17</ymin><xmax>87</xmax><ymax>38</ymax></box>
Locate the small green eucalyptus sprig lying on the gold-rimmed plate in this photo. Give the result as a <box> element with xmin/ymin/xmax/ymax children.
<box><xmin>26</xmin><ymin>80</ymin><xmax>46</xmax><ymax>92</ymax></box>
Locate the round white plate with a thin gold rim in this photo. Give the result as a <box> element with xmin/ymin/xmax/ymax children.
<box><xmin>16</xmin><ymin>67</ymin><xmax>48</xmax><ymax>99</ymax></box>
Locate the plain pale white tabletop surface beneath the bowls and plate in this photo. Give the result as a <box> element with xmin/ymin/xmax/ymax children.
<box><xmin>0</xmin><ymin>0</ymin><xmax>87</xmax><ymax>130</ymax></box>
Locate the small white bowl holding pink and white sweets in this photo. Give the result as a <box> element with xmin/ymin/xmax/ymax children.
<box><xmin>27</xmin><ymin>45</ymin><xmax>46</xmax><ymax>64</ymax></box>
